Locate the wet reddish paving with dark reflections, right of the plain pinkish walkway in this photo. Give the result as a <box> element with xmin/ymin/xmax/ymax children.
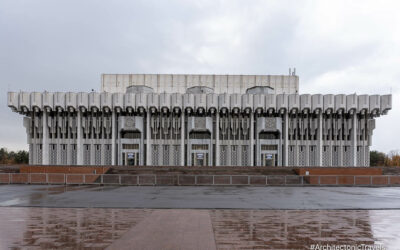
<box><xmin>211</xmin><ymin>210</ymin><xmax>400</xmax><ymax>249</ymax></box>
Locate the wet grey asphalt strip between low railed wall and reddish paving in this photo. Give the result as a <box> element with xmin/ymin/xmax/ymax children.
<box><xmin>0</xmin><ymin>185</ymin><xmax>400</xmax><ymax>209</ymax></box>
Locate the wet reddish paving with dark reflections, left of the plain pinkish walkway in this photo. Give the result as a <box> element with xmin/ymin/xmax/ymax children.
<box><xmin>0</xmin><ymin>207</ymin><xmax>151</xmax><ymax>249</ymax></box>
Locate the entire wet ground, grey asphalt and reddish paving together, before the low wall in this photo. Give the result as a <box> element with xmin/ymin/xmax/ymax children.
<box><xmin>0</xmin><ymin>185</ymin><xmax>400</xmax><ymax>249</ymax></box>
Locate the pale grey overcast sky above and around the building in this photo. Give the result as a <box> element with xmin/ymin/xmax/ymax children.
<box><xmin>0</xmin><ymin>0</ymin><xmax>400</xmax><ymax>152</ymax></box>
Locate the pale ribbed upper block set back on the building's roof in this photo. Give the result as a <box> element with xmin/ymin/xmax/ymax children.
<box><xmin>101</xmin><ymin>74</ymin><xmax>299</xmax><ymax>94</ymax></box>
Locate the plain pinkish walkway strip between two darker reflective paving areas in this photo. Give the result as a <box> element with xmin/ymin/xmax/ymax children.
<box><xmin>107</xmin><ymin>210</ymin><xmax>216</xmax><ymax>250</ymax></box>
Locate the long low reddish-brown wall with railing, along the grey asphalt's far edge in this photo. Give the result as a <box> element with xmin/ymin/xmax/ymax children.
<box><xmin>0</xmin><ymin>173</ymin><xmax>400</xmax><ymax>186</ymax></box>
